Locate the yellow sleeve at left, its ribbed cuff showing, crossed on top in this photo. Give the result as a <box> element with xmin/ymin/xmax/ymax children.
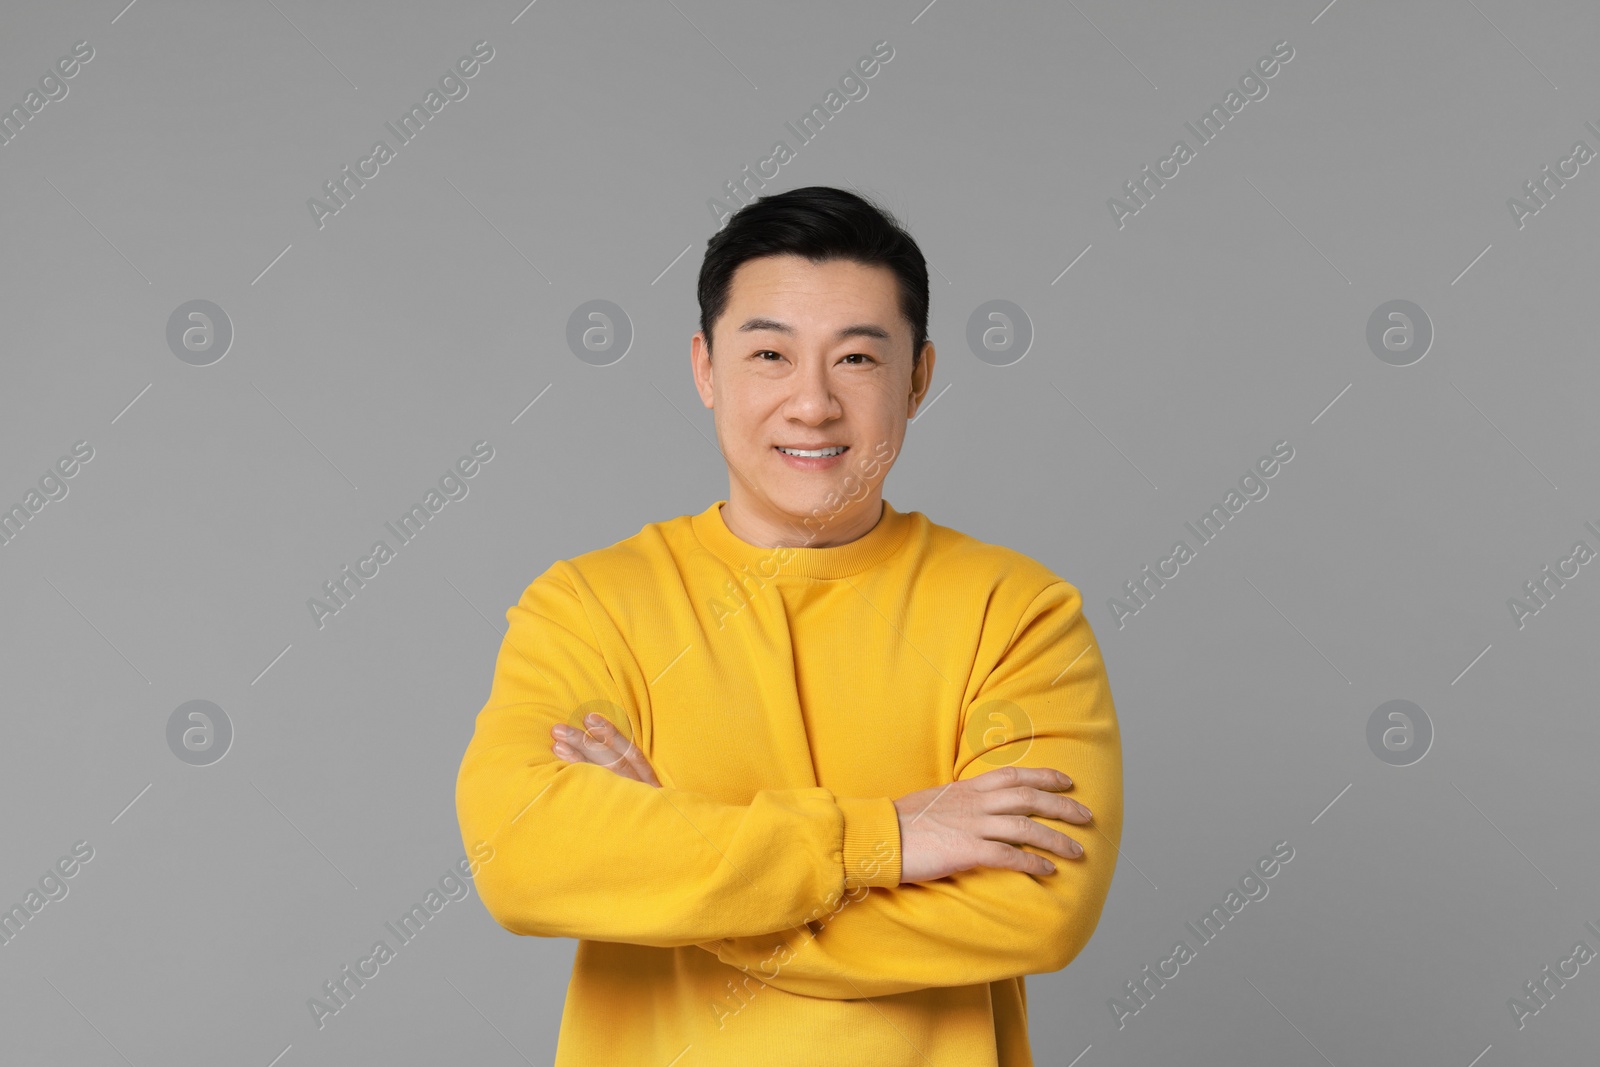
<box><xmin>456</xmin><ymin>563</ymin><xmax>899</xmax><ymax>947</ymax></box>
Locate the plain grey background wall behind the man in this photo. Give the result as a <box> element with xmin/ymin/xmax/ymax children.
<box><xmin>0</xmin><ymin>0</ymin><xmax>1600</xmax><ymax>1067</ymax></box>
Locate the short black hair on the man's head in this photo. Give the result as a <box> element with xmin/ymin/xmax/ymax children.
<box><xmin>698</xmin><ymin>186</ymin><xmax>928</xmax><ymax>370</ymax></box>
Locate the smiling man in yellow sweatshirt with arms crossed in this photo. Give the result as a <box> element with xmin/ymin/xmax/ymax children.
<box><xmin>456</xmin><ymin>187</ymin><xmax>1122</xmax><ymax>1067</ymax></box>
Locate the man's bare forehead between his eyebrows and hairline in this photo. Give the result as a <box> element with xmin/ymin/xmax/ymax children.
<box><xmin>723</xmin><ymin>256</ymin><xmax>907</xmax><ymax>331</ymax></box>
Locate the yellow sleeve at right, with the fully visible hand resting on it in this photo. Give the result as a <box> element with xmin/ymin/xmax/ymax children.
<box><xmin>701</xmin><ymin>581</ymin><xmax>1122</xmax><ymax>1000</ymax></box>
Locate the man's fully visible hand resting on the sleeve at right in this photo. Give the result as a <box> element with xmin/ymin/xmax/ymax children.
<box><xmin>894</xmin><ymin>766</ymin><xmax>1093</xmax><ymax>885</ymax></box>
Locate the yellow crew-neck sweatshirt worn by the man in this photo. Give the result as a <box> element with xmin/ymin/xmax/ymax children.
<box><xmin>456</xmin><ymin>501</ymin><xmax>1122</xmax><ymax>1067</ymax></box>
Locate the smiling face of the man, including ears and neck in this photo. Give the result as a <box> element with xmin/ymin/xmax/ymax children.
<box><xmin>693</xmin><ymin>256</ymin><xmax>934</xmax><ymax>547</ymax></box>
